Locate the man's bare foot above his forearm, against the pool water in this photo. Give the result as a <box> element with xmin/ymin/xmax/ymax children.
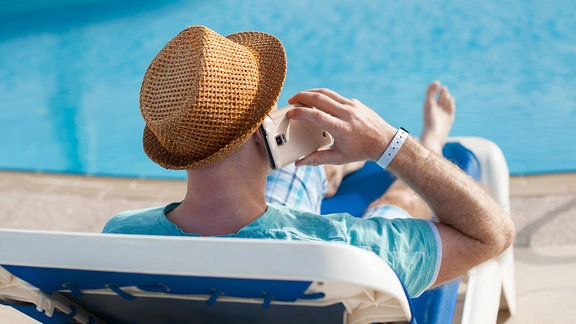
<box><xmin>420</xmin><ymin>81</ymin><xmax>456</xmax><ymax>153</ymax></box>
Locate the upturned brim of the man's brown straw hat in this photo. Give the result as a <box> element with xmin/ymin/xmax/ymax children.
<box><xmin>143</xmin><ymin>28</ymin><xmax>286</xmax><ymax>170</ymax></box>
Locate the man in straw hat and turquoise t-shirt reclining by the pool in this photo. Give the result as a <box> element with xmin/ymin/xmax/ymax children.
<box><xmin>104</xmin><ymin>26</ymin><xmax>513</xmax><ymax>296</ymax></box>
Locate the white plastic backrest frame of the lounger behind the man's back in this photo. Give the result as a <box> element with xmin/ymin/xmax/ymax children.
<box><xmin>0</xmin><ymin>230</ymin><xmax>411</xmax><ymax>323</ymax></box>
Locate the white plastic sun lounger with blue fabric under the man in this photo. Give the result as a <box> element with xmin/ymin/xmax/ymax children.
<box><xmin>0</xmin><ymin>138</ymin><xmax>515</xmax><ymax>323</ymax></box>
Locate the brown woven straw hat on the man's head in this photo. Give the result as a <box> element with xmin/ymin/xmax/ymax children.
<box><xmin>140</xmin><ymin>26</ymin><xmax>286</xmax><ymax>170</ymax></box>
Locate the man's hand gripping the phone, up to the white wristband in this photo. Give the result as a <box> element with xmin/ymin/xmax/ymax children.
<box><xmin>287</xmin><ymin>89</ymin><xmax>396</xmax><ymax>165</ymax></box>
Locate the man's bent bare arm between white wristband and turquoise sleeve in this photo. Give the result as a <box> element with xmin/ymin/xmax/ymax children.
<box><xmin>388</xmin><ymin>138</ymin><xmax>514</xmax><ymax>284</ymax></box>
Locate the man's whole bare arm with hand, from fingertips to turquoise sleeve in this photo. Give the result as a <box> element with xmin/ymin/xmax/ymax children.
<box><xmin>288</xmin><ymin>89</ymin><xmax>514</xmax><ymax>284</ymax></box>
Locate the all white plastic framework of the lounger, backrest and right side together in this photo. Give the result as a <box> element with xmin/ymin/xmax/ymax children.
<box><xmin>0</xmin><ymin>137</ymin><xmax>516</xmax><ymax>324</ymax></box>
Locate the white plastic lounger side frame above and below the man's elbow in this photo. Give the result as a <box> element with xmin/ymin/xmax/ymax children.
<box><xmin>450</xmin><ymin>137</ymin><xmax>516</xmax><ymax>324</ymax></box>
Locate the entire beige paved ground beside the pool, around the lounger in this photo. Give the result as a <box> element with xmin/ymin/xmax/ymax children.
<box><xmin>0</xmin><ymin>172</ymin><xmax>576</xmax><ymax>324</ymax></box>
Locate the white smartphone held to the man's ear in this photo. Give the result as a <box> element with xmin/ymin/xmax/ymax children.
<box><xmin>260</xmin><ymin>105</ymin><xmax>334</xmax><ymax>169</ymax></box>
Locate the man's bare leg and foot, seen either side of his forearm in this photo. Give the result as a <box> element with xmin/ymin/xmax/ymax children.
<box><xmin>368</xmin><ymin>81</ymin><xmax>456</xmax><ymax>219</ymax></box>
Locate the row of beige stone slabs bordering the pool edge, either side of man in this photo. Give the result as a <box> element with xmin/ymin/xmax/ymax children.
<box><xmin>0</xmin><ymin>171</ymin><xmax>576</xmax><ymax>246</ymax></box>
